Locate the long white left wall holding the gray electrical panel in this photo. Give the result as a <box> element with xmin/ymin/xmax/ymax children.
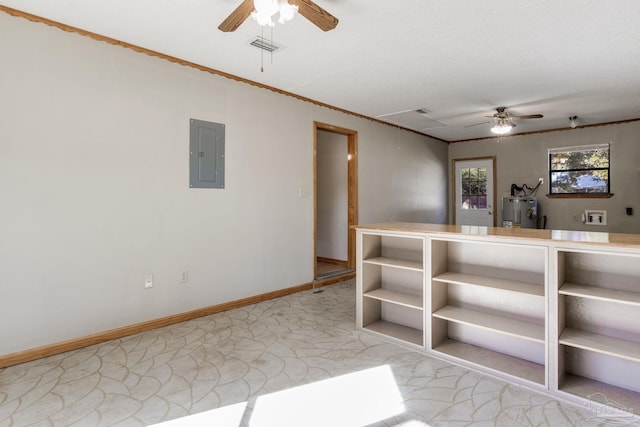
<box><xmin>0</xmin><ymin>13</ymin><xmax>447</xmax><ymax>355</ymax></box>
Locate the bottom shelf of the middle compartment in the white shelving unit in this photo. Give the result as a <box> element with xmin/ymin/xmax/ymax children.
<box><xmin>434</xmin><ymin>339</ymin><xmax>545</xmax><ymax>385</ymax></box>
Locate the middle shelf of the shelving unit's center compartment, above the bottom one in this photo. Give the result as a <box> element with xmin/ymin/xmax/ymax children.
<box><xmin>433</xmin><ymin>305</ymin><xmax>545</xmax><ymax>343</ymax></box>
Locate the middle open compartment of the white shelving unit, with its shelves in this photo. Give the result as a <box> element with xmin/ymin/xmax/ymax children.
<box><xmin>430</xmin><ymin>238</ymin><xmax>547</xmax><ymax>385</ymax></box>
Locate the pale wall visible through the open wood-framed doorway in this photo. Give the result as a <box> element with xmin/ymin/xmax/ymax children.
<box><xmin>316</xmin><ymin>130</ymin><xmax>349</xmax><ymax>261</ymax></box>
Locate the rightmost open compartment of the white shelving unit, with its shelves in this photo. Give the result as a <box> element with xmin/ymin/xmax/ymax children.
<box><xmin>556</xmin><ymin>249</ymin><xmax>640</xmax><ymax>408</ymax></box>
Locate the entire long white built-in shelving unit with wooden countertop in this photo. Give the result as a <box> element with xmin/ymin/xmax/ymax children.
<box><xmin>356</xmin><ymin>223</ymin><xmax>640</xmax><ymax>424</ymax></box>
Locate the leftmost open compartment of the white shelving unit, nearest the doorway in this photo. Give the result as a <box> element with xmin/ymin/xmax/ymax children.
<box><xmin>358</xmin><ymin>233</ymin><xmax>425</xmax><ymax>348</ymax></box>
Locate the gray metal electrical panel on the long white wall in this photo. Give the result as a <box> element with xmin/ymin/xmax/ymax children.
<box><xmin>189</xmin><ymin>119</ymin><xmax>224</xmax><ymax>188</ymax></box>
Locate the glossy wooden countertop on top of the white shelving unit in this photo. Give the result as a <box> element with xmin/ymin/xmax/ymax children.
<box><xmin>354</xmin><ymin>222</ymin><xmax>640</xmax><ymax>249</ymax></box>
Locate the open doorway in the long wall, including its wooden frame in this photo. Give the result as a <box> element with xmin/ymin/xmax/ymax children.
<box><xmin>313</xmin><ymin>122</ymin><xmax>358</xmax><ymax>281</ymax></box>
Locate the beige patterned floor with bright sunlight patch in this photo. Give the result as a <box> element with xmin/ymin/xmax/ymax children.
<box><xmin>0</xmin><ymin>280</ymin><xmax>628</xmax><ymax>427</ymax></box>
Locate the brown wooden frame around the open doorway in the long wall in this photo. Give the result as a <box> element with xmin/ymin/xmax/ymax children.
<box><xmin>313</xmin><ymin>122</ymin><xmax>358</xmax><ymax>280</ymax></box>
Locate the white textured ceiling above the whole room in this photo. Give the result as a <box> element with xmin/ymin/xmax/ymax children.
<box><xmin>0</xmin><ymin>0</ymin><xmax>640</xmax><ymax>141</ymax></box>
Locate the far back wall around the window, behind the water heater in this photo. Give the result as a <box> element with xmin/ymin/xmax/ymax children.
<box><xmin>449</xmin><ymin>121</ymin><xmax>640</xmax><ymax>233</ymax></box>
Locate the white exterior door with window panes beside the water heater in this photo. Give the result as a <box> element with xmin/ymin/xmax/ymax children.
<box><xmin>454</xmin><ymin>158</ymin><xmax>495</xmax><ymax>227</ymax></box>
